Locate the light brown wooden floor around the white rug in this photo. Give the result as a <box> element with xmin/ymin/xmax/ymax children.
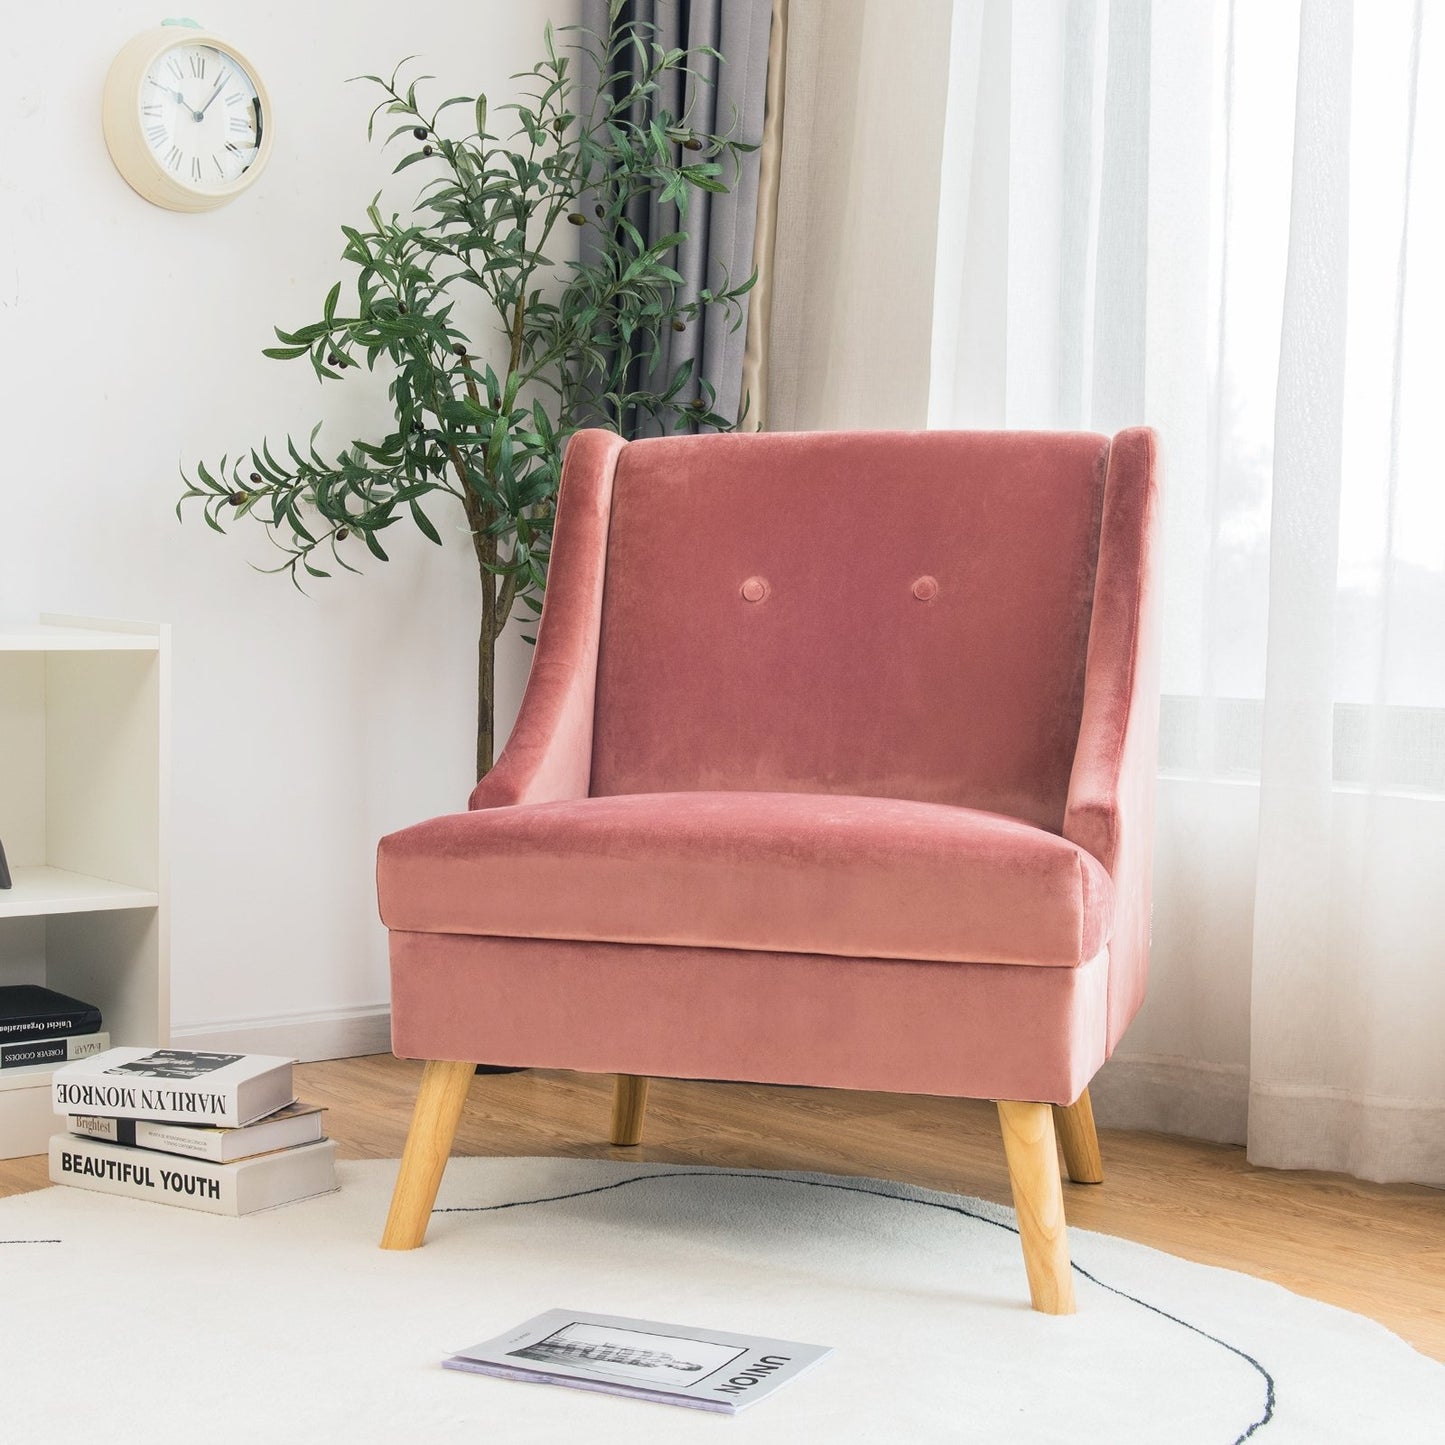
<box><xmin>0</xmin><ymin>1055</ymin><xmax>1445</xmax><ymax>1360</ymax></box>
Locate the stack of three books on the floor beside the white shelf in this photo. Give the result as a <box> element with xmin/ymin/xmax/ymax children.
<box><xmin>51</xmin><ymin>1049</ymin><xmax>337</xmax><ymax>1214</ymax></box>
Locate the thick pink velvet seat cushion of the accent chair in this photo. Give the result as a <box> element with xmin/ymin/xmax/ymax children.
<box><xmin>377</xmin><ymin>792</ymin><xmax>1114</xmax><ymax>968</ymax></box>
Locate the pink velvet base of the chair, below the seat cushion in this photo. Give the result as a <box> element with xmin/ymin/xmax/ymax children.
<box><xmin>392</xmin><ymin>932</ymin><xmax>1108</xmax><ymax>1104</ymax></box>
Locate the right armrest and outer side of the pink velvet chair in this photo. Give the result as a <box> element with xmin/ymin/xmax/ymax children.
<box><xmin>1064</xmin><ymin>426</ymin><xmax>1159</xmax><ymax>1049</ymax></box>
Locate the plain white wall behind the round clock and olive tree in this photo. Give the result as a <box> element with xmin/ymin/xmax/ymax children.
<box><xmin>0</xmin><ymin>0</ymin><xmax>579</xmax><ymax>1051</ymax></box>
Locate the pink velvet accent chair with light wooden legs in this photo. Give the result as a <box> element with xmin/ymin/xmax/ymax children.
<box><xmin>379</xmin><ymin>429</ymin><xmax>1157</xmax><ymax>1314</ymax></box>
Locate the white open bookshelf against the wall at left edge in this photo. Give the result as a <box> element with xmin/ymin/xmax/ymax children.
<box><xmin>0</xmin><ymin>617</ymin><xmax>171</xmax><ymax>1159</ymax></box>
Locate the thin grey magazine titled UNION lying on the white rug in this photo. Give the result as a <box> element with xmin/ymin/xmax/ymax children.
<box><xmin>442</xmin><ymin>1309</ymin><xmax>832</xmax><ymax>1415</ymax></box>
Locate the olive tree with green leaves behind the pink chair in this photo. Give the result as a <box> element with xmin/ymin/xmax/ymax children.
<box><xmin>176</xmin><ymin>11</ymin><xmax>753</xmax><ymax>776</ymax></box>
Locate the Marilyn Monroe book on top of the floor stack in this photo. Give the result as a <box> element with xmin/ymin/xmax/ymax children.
<box><xmin>51</xmin><ymin>1049</ymin><xmax>295</xmax><ymax>1129</ymax></box>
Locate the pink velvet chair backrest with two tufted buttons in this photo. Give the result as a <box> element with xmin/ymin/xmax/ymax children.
<box><xmin>591</xmin><ymin>432</ymin><xmax>1110</xmax><ymax>831</ymax></box>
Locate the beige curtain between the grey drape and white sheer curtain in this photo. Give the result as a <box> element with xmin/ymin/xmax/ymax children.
<box><xmin>763</xmin><ymin>0</ymin><xmax>952</xmax><ymax>431</ymax></box>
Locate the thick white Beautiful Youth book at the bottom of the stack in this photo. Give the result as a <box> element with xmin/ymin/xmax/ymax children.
<box><xmin>51</xmin><ymin>1134</ymin><xmax>337</xmax><ymax>1214</ymax></box>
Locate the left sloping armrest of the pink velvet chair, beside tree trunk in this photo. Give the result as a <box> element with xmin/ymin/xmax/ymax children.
<box><xmin>470</xmin><ymin>431</ymin><xmax>624</xmax><ymax>808</ymax></box>
